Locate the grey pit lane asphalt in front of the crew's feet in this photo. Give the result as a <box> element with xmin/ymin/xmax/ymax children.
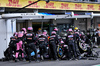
<box><xmin>0</xmin><ymin>48</ymin><xmax>100</xmax><ymax>66</ymax></box>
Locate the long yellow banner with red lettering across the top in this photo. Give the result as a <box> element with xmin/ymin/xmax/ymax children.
<box><xmin>0</xmin><ymin>0</ymin><xmax>100</xmax><ymax>11</ymax></box>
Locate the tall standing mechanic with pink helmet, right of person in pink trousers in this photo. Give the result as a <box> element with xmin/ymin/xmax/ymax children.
<box><xmin>25</xmin><ymin>27</ymin><xmax>38</xmax><ymax>62</ymax></box>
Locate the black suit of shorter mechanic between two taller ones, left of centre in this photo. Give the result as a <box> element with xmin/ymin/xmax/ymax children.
<box><xmin>38</xmin><ymin>36</ymin><xmax>48</xmax><ymax>57</ymax></box>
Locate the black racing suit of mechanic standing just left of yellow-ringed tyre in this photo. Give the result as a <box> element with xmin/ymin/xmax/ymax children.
<box><xmin>49</xmin><ymin>35</ymin><xmax>58</xmax><ymax>60</ymax></box>
